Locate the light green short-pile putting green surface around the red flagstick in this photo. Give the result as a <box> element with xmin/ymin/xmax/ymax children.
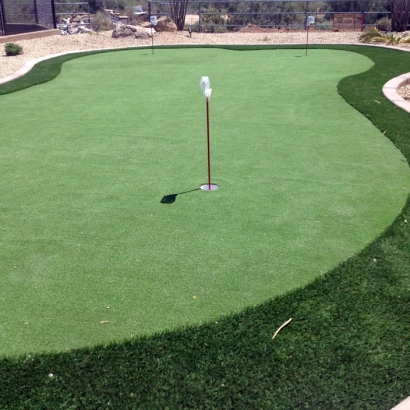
<box><xmin>0</xmin><ymin>49</ymin><xmax>409</xmax><ymax>355</ymax></box>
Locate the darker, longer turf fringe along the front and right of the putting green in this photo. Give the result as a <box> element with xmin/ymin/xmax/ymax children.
<box><xmin>0</xmin><ymin>47</ymin><xmax>410</xmax><ymax>409</ymax></box>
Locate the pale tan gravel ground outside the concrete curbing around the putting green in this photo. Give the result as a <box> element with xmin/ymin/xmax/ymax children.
<box><xmin>0</xmin><ymin>27</ymin><xmax>410</xmax><ymax>98</ymax></box>
